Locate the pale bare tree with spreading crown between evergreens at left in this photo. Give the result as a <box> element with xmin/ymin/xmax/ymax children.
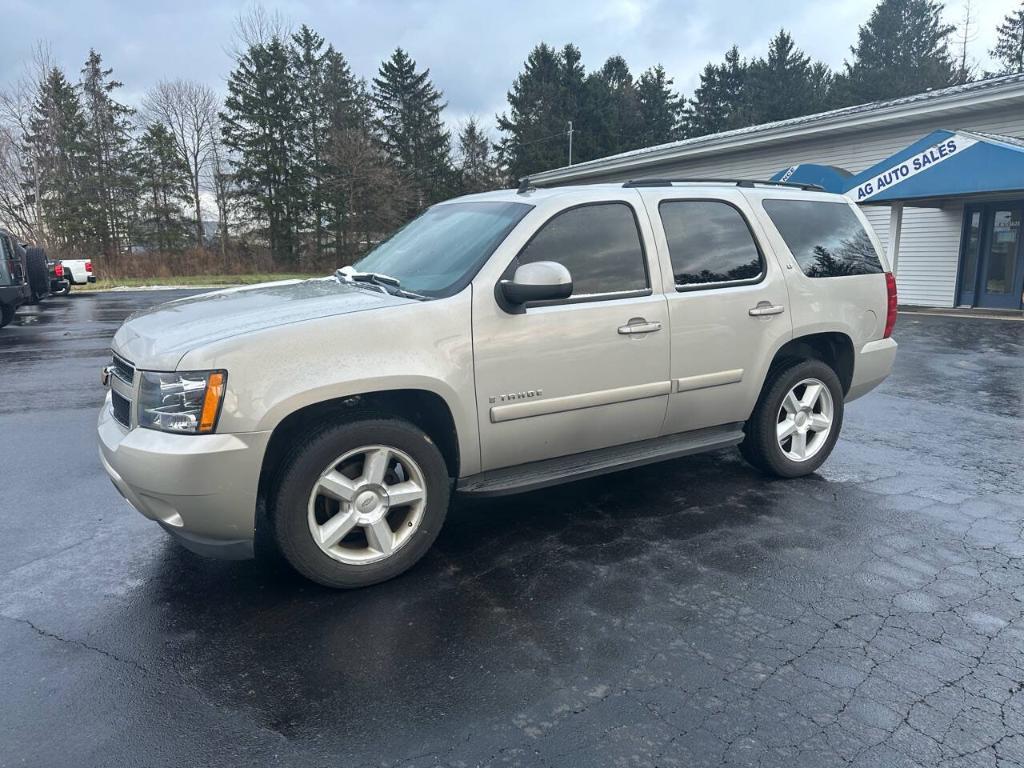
<box><xmin>142</xmin><ymin>80</ymin><xmax>218</xmax><ymax>248</ymax></box>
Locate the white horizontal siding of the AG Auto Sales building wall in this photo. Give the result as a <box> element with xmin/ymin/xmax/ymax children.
<box><xmin>561</xmin><ymin>109</ymin><xmax>1024</xmax><ymax>306</ymax></box>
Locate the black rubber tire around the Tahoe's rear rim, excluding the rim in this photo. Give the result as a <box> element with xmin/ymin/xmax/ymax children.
<box><xmin>739</xmin><ymin>359</ymin><xmax>843</xmax><ymax>477</ymax></box>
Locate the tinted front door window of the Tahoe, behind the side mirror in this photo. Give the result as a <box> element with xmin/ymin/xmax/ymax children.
<box><xmin>519</xmin><ymin>203</ymin><xmax>647</xmax><ymax>297</ymax></box>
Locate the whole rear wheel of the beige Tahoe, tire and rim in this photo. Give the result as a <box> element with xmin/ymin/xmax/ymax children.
<box><xmin>739</xmin><ymin>359</ymin><xmax>843</xmax><ymax>477</ymax></box>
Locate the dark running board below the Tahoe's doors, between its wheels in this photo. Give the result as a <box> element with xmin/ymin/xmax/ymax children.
<box><xmin>456</xmin><ymin>422</ymin><xmax>743</xmax><ymax>497</ymax></box>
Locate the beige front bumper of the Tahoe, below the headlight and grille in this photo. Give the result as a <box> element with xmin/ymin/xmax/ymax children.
<box><xmin>96</xmin><ymin>393</ymin><xmax>270</xmax><ymax>559</ymax></box>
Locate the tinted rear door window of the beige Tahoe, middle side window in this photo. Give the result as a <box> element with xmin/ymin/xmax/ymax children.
<box><xmin>658</xmin><ymin>200</ymin><xmax>764</xmax><ymax>286</ymax></box>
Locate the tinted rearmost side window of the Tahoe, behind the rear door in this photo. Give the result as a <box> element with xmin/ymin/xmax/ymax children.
<box><xmin>764</xmin><ymin>200</ymin><xmax>883</xmax><ymax>278</ymax></box>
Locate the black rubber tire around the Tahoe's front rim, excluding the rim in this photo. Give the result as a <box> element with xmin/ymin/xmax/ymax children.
<box><xmin>269</xmin><ymin>417</ymin><xmax>451</xmax><ymax>589</ymax></box>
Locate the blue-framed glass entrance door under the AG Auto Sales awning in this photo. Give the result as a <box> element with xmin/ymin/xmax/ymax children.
<box><xmin>959</xmin><ymin>204</ymin><xmax>1024</xmax><ymax>309</ymax></box>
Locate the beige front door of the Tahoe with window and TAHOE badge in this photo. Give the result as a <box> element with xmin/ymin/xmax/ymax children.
<box><xmin>473</xmin><ymin>196</ymin><xmax>670</xmax><ymax>470</ymax></box>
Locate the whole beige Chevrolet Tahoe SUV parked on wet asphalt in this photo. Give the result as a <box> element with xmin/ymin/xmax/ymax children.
<box><xmin>98</xmin><ymin>180</ymin><xmax>896</xmax><ymax>588</ymax></box>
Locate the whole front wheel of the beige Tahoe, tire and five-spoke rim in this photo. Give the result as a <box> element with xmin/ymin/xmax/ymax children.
<box><xmin>270</xmin><ymin>418</ymin><xmax>450</xmax><ymax>588</ymax></box>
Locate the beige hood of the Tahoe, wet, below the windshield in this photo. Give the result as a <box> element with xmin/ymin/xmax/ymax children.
<box><xmin>113</xmin><ymin>278</ymin><xmax>413</xmax><ymax>371</ymax></box>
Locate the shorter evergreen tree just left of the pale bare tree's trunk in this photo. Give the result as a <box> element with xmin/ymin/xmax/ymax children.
<box><xmin>136</xmin><ymin>123</ymin><xmax>190</xmax><ymax>253</ymax></box>
